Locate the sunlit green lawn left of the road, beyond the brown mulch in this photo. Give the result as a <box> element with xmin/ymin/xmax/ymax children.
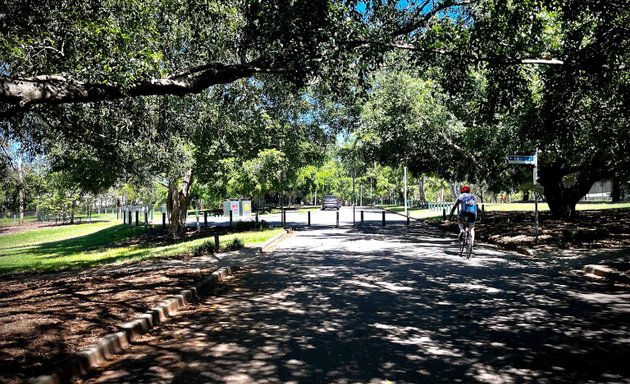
<box><xmin>0</xmin><ymin>222</ymin><xmax>283</xmax><ymax>275</ymax></box>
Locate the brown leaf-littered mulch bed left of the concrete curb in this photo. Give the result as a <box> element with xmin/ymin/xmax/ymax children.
<box><xmin>0</xmin><ymin>223</ymin><xmax>235</xmax><ymax>384</ymax></box>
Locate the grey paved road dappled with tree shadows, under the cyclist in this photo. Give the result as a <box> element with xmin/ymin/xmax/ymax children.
<box><xmin>79</xmin><ymin>226</ymin><xmax>630</xmax><ymax>383</ymax></box>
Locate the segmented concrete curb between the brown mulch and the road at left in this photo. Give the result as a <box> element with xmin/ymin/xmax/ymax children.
<box><xmin>28</xmin><ymin>266</ymin><xmax>238</xmax><ymax>384</ymax></box>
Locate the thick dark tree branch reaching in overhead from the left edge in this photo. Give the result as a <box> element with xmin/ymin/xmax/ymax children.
<box><xmin>0</xmin><ymin>59</ymin><xmax>279</xmax><ymax>107</ymax></box>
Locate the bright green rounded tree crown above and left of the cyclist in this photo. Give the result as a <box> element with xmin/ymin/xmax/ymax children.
<box><xmin>359</xmin><ymin>72</ymin><xmax>463</xmax><ymax>177</ymax></box>
